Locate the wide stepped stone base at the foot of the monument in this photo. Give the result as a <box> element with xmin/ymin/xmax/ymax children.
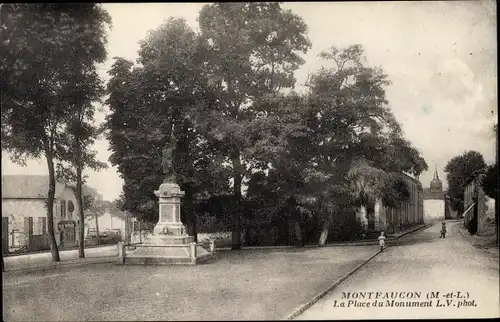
<box><xmin>124</xmin><ymin>244</ymin><xmax>215</xmax><ymax>265</ymax></box>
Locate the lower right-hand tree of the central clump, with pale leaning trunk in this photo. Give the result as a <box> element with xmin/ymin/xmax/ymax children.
<box><xmin>249</xmin><ymin>45</ymin><xmax>427</xmax><ymax>245</ymax></box>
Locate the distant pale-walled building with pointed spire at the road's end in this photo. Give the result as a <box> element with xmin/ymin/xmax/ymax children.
<box><xmin>424</xmin><ymin>168</ymin><xmax>446</xmax><ymax>222</ymax></box>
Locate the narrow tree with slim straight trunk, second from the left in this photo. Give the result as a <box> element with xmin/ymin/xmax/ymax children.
<box><xmin>54</xmin><ymin>6</ymin><xmax>111</xmax><ymax>258</ymax></box>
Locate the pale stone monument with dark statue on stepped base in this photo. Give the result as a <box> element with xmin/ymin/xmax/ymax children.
<box><xmin>122</xmin><ymin>140</ymin><xmax>214</xmax><ymax>265</ymax></box>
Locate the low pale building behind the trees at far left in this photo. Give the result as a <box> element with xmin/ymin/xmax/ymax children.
<box><xmin>2</xmin><ymin>175</ymin><xmax>79</xmax><ymax>251</ymax></box>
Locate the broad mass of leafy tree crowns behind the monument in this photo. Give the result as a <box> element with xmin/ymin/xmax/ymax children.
<box><xmin>106</xmin><ymin>3</ymin><xmax>427</xmax><ymax>249</ymax></box>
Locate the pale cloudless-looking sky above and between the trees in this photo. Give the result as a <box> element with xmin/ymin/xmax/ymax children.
<box><xmin>2</xmin><ymin>1</ymin><xmax>498</xmax><ymax>200</ymax></box>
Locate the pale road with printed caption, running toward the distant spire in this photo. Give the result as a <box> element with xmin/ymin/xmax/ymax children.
<box><xmin>297</xmin><ymin>223</ymin><xmax>500</xmax><ymax>320</ymax></box>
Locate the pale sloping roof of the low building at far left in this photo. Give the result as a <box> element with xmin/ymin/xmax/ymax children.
<box><xmin>2</xmin><ymin>175</ymin><xmax>66</xmax><ymax>199</ymax></box>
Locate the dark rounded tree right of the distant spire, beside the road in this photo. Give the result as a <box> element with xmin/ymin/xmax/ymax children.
<box><xmin>444</xmin><ymin>151</ymin><xmax>486</xmax><ymax>214</ymax></box>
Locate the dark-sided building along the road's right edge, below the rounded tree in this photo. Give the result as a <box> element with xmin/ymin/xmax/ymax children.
<box><xmin>463</xmin><ymin>169</ymin><xmax>495</xmax><ymax>236</ymax></box>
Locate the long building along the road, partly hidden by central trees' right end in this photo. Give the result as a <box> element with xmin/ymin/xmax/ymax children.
<box><xmin>358</xmin><ymin>173</ymin><xmax>424</xmax><ymax>234</ymax></box>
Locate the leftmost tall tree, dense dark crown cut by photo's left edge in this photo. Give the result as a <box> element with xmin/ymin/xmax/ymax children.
<box><xmin>1</xmin><ymin>4</ymin><xmax>110</xmax><ymax>261</ymax></box>
